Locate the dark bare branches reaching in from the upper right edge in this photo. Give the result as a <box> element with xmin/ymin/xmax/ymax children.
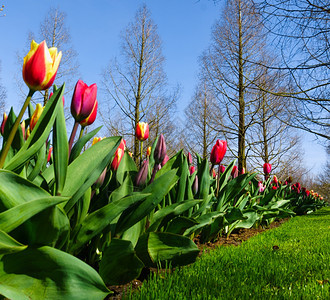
<box><xmin>256</xmin><ymin>0</ymin><xmax>330</xmax><ymax>139</ymax></box>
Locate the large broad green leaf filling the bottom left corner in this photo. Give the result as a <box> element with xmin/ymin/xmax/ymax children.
<box><xmin>0</xmin><ymin>246</ymin><xmax>110</xmax><ymax>300</ymax></box>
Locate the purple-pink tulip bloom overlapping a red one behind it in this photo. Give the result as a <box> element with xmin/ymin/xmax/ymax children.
<box><xmin>71</xmin><ymin>80</ymin><xmax>97</xmax><ymax>122</ymax></box>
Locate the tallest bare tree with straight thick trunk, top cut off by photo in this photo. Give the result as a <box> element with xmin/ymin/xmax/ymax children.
<box><xmin>202</xmin><ymin>0</ymin><xmax>265</xmax><ymax>170</ymax></box>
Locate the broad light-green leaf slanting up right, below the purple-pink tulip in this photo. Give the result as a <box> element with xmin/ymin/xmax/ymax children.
<box><xmin>62</xmin><ymin>137</ymin><xmax>121</xmax><ymax>212</ymax></box>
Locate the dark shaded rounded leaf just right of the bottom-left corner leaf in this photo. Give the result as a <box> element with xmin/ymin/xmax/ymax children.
<box><xmin>100</xmin><ymin>239</ymin><xmax>144</xmax><ymax>285</ymax></box>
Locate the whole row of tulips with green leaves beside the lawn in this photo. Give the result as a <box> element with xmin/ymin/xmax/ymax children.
<box><xmin>0</xmin><ymin>42</ymin><xmax>323</xmax><ymax>299</ymax></box>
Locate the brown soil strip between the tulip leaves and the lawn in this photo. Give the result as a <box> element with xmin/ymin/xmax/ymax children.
<box><xmin>106</xmin><ymin>218</ymin><xmax>289</xmax><ymax>300</ymax></box>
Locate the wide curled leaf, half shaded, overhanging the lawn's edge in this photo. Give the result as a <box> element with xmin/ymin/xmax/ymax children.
<box><xmin>135</xmin><ymin>232</ymin><xmax>199</xmax><ymax>267</ymax></box>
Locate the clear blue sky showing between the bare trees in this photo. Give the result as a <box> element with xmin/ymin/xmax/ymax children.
<box><xmin>0</xmin><ymin>0</ymin><xmax>326</xmax><ymax>173</ymax></box>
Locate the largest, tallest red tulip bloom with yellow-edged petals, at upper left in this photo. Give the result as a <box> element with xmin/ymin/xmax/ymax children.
<box><xmin>23</xmin><ymin>41</ymin><xmax>62</xmax><ymax>91</ymax></box>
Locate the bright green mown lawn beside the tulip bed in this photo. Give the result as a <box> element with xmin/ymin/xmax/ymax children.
<box><xmin>126</xmin><ymin>207</ymin><xmax>330</xmax><ymax>300</ymax></box>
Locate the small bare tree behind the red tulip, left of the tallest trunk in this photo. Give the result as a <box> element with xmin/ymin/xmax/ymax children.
<box><xmin>185</xmin><ymin>83</ymin><xmax>221</xmax><ymax>158</ymax></box>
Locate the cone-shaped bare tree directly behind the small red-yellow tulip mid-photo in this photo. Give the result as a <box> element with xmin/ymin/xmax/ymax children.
<box><xmin>103</xmin><ymin>5</ymin><xmax>177</xmax><ymax>163</ymax></box>
